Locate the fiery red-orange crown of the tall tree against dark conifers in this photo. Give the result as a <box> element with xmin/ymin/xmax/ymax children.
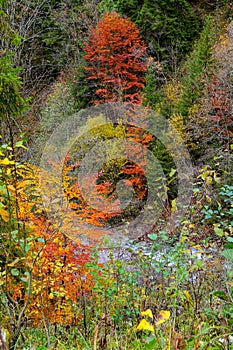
<box><xmin>85</xmin><ymin>12</ymin><xmax>146</xmax><ymax>104</ymax></box>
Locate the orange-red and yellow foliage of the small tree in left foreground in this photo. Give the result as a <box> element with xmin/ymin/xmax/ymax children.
<box><xmin>9</xmin><ymin>166</ymin><xmax>93</xmax><ymax>327</ymax></box>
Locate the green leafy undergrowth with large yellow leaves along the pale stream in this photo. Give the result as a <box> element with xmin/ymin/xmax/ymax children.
<box><xmin>18</xmin><ymin>230</ymin><xmax>233</xmax><ymax>350</ymax></box>
